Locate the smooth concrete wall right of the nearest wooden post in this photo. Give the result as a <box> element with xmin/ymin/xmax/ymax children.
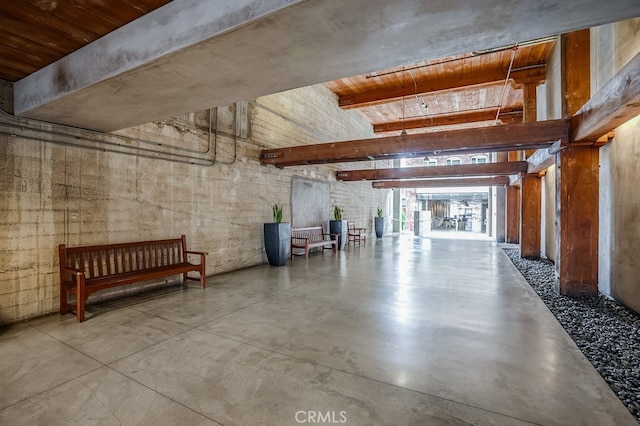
<box><xmin>591</xmin><ymin>19</ymin><xmax>640</xmax><ymax>312</ymax></box>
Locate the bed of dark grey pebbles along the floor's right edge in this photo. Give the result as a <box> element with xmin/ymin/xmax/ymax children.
<box><xmin>504</xmin><ymin>248</ymin><xmax>640</xmax><ymax>423</ymax></box>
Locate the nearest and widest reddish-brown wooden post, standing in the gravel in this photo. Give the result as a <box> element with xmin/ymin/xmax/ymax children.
<box><xmin>556</xmin><ymin>29</ymin><xmax>599</xmax><ymax>296</ymax></box>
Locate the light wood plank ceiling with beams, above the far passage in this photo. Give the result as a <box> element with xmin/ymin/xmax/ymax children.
<box><xmin>326</xmin><ymin>38</ymin><xmax>555</xmax><ymax>136</ymax></box>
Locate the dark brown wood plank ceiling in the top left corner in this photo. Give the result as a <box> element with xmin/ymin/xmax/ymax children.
<box><xmin>0</xmin><ymin>0</ymin><xmax>170</xmax><ymax>82</ymax></box>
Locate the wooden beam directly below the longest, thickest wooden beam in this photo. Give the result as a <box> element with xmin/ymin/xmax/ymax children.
<box><xmin>336</xmin><ymin>161</ymin><xmax>528</xmax><ymax>181</ymax></box>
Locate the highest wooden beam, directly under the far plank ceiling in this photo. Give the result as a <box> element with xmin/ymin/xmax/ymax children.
<box><xmin>338</xmin><ymin>65</ymin><xmax>546</xmax><ymax>109</ymax></box>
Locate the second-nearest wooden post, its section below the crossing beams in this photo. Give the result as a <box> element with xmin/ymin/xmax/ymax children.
<box><xmin>520</xmin><ymin>174</ymin><xmax>542</xmax><ymax>259</ymax></box>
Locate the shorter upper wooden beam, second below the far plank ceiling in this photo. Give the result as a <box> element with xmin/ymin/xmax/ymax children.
<box><xmin>373</xmin><ymin>108</ymin><xmax>523</xmax><ymax>133</ymax></box>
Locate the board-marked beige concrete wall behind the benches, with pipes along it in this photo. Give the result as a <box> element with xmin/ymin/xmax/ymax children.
<box><xmin>0</xmin><ymin>84</ymin><xmax>388</xmax><ymax>325</ymax></box>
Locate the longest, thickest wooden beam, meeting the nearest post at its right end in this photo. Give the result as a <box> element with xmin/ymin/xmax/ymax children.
<box><xmin>260</xmin><ymin>120</ymin><xmax>569</xmax><ymax>167</ymax></box>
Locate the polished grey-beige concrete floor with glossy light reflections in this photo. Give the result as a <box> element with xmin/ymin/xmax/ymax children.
<box><xmin>0</xmin><ymin>235</ymin><xmax>636</xmax><ymax>426</ymax></box>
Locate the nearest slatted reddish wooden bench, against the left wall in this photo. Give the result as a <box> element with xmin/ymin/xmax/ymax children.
<box><xmin>58</xmin><ymin>235</ymin><xmax>207</xmax><ymax>322</ymax></box>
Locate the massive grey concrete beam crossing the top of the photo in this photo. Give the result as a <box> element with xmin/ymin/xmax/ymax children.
<box><xmin>14</xmin><ymin>0</ymin><xmax>640</xmax><ymax>131</ymax></box>
